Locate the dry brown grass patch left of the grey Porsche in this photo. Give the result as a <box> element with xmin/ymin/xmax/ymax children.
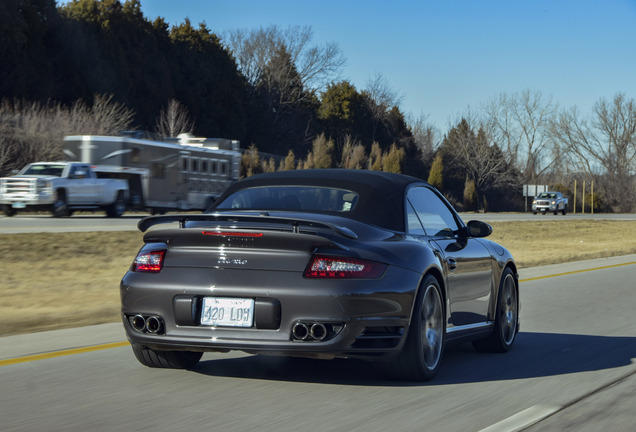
<box><xmin>0</xmin><ymin>231</ymin><xmax>142</xmax><ymax>335</ymax></box>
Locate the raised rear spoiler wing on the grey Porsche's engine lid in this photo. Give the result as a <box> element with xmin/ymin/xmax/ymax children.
<box><xmin>137</xmin><ymin>212</ymin><xmax>358</xmax><ymax>239</ymax></box>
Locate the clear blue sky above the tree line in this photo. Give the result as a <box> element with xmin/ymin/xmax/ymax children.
<box><xmin>141</xmin><ymin>0</ymin><xmax>636</xmax><ymax>132</ymax></box>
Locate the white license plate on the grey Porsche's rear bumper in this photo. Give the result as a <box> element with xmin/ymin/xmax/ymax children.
<box><xmin>201</xmin><ymin>297</ymin><xmax>254</xmax><ymax>327</ymax></box>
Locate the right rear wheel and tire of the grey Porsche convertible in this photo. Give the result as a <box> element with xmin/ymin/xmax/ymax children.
<box><xmin>387</xmin><ymin>275</ymin><xmax>446</xmax><ymax>381</ymax></box>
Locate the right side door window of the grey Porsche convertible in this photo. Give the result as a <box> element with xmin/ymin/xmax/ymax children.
<box><xmin>408</xmin><ymin>187</ymin><xmax>459</xmax><ymax>237</ymax></box>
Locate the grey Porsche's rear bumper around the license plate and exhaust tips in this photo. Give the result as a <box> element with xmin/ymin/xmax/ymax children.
<box><xmin>121</xmin><ymin>267</ymin><xmax>421</xmax><ymax>359</ymax></box>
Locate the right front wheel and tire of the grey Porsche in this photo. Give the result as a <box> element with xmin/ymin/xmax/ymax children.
<box><xmin>473</xmin><ymin>267</ymin><xmax>519</xmax><ymax>353</ymax></box>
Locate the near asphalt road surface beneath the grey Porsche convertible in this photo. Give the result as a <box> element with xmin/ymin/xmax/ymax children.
<box><xmin>0</xmin><ymin>255</ymin><xmax>636</xmax><ymax>432</ymax></box>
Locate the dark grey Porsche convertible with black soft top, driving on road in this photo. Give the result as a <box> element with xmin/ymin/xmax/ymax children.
<box><xmin>120</xmin><ymin>169</ymin><xmax>519</xmax><ymax>381</ymax></box>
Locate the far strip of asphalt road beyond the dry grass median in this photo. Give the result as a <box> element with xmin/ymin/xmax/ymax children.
<box><xmin>0</xmin><ymin>213</ymin><xmax>636</xmax><ymax>234</ymax></box>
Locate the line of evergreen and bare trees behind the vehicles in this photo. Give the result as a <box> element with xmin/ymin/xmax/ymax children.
<box><xmin>0</xmin><ymin>0</ymin><xmax>636</xmax><ymax>211</ymax></box>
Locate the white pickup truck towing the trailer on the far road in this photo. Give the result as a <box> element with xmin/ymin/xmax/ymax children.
<box><xmin>0</xmin><ymin>162</ymin><xmax>128</xmax><ymax>217</ymax></box>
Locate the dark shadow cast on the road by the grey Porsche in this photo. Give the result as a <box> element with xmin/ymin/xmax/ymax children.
<box><xmin>193</xmin><ymin>332</ymin><xmax>636</xmax><ymax>387</ymax></box>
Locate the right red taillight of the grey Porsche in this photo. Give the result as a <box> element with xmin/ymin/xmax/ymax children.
<box><xmin>304</xmin><ymin>255</ymin><xmax>387</xmax><ymax>279</ymax></box>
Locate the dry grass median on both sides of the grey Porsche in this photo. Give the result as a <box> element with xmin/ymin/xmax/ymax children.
<box><xmin>0</xmin><ymin>218</ymin><xmax>636</xmax><ymax>336</ymax></box>
